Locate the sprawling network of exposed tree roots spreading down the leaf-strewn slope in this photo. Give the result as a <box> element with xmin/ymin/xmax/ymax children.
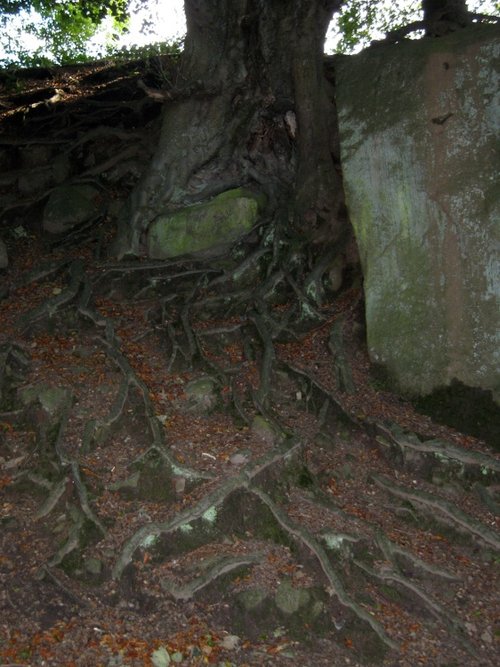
<box><xmin>0</xmin><ymin>197</ymin><xmax>500</xmax><ymax>655</ymax></box>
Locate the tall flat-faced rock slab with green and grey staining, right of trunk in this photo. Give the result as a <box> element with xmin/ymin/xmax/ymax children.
<box><xmin>337</xmin><ymin>26</ymin><xmax>500</xmax><ymax>402</ymax></box>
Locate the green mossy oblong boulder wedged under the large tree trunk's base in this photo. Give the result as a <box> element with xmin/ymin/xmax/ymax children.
<box><xmin>147</xmin><ymin>188</ymin><xmax>262</xmax><ymax>259</ymax></box>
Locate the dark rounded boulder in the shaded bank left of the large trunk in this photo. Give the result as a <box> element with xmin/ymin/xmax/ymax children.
<box><xmin>43</xmin><ymin>185</ymin><xmax>103</xmax><ymax>234</ymax></box>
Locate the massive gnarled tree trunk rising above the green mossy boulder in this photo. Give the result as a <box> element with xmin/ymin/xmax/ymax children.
<box><xmin>115</xmin><ymin>0</ymin><xmax>345</xmax><ymax>255</ymax></box>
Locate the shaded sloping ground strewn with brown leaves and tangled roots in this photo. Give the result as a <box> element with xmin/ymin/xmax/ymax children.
<box><xmin>0</xmin><ymin>61</ymin><xmax>500</xmax><ymax>667</ymax></box>
